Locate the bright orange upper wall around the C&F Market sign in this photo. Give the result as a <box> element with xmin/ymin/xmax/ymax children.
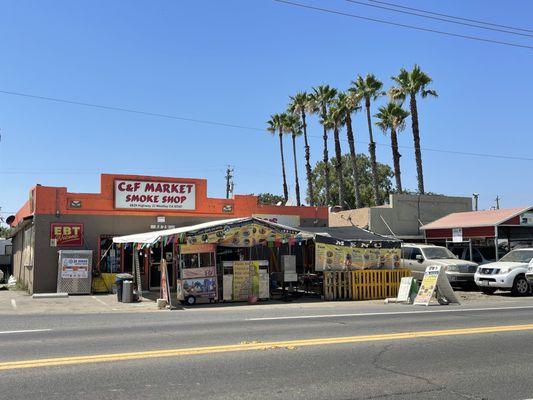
<box><xmin>13</xmin><ymin>174</ymin><xmax>328</xmax><ymax>225</ymax></box>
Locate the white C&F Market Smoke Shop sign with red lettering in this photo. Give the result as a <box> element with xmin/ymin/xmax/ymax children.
<box><xmin>115</xmin><ymin>179</ymin><xmax>196</xmax><ymax>210</ymax></box>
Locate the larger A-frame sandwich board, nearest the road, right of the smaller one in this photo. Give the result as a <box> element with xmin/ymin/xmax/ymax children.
<box><xmin>413</xmin><ymin>265</ymin><xmax>460</xmax><ymax>306</ymax></box>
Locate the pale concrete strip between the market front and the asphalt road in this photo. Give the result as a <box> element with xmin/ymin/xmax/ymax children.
<box><xmin>0</xmin><ymin>290</ymin><xmax>533</xmax><ymax>315</ymax></box>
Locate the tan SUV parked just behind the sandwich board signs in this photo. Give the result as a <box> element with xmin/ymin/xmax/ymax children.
<box><xmin>402</xmin><ymin>243</ymin><xmax>478</xmax><ymax>286</ymax></box>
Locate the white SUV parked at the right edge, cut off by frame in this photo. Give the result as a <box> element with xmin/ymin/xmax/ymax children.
<box><xmin>474</xmin><ymin>248</ymin><xmax>533</xmax><ymax>296</ymax></box>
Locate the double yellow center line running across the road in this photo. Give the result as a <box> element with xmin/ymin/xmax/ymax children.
<box><xmin>0</xmin><ymin>324</ymin><xmax>533</xmax><ymax>371</ymax></box>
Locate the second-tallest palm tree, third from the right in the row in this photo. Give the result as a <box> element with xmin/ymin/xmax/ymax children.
<box><xmin>349</xmin><ymin>74</ymin><xmax>385</xmax><ymax>205</ymax></box>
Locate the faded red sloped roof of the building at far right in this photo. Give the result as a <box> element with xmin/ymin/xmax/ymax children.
<box><xmin>420</xmin><ymin>206</ymin><xmax>533</xmax><ymax>230</ymax></box>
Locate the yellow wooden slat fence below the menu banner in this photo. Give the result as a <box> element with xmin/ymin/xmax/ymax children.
<box><xmin>324</xmin><ymin>269</ymin><xmax>411</xmax><ymax>300</ymax></box>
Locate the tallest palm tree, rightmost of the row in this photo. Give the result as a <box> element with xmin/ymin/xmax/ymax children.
<box><xmin>390</xmin><ymin>64</ymin><xmax>438</xmax><ymax>194</ymax></box>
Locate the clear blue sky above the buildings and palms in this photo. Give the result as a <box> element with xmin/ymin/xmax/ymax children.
<box><xmin>0</xmin><ymin>0</ymin><xmax>533</xmax><ymax>216</ymax></box>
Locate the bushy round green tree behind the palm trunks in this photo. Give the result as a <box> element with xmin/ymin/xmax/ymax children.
<box><xmin>313</xmin><ymin>154</ymin><xmax>393</xmax><ymax>208</ymax></box>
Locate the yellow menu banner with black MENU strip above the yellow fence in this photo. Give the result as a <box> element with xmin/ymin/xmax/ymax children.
<box><xmin>315</xmin><ymin>236</ymin><xmax>401</xmax><ymax>271</ymax></box>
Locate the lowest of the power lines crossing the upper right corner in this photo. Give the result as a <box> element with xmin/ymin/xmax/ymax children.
<box><xmin>273</xmin><ymin>0</ymin><xmax>533</xmax><ymax>50</ymax></box>
